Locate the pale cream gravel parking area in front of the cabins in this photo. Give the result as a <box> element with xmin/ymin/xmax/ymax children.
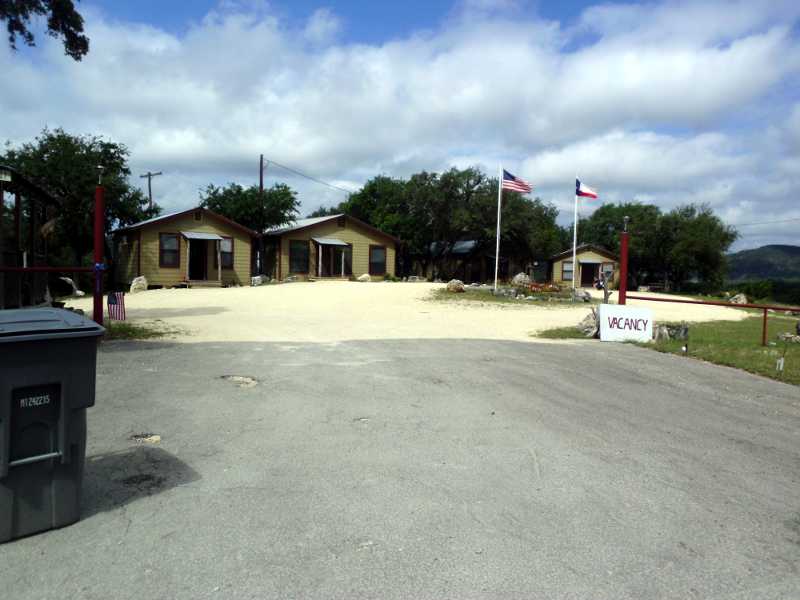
<box><xmin>65</xmin><ymin>281</ymin><xmax>746</xmax><ymax>342</ymax></box>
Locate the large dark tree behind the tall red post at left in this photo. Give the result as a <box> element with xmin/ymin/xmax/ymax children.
<box><xmin>0</xmin><ymin>129</ymin><xmax>161</xmax><ymax>264</ymax></box>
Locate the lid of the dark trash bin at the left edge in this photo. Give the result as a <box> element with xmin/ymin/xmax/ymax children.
<box><xmin>0</xmin><ymin>308</ymin><xmax>106</xmax><ymax>344</ymax></box>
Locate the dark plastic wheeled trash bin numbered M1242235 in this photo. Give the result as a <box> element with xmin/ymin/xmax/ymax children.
<box><xmin>0</xmin><ymin>308</ymin><xmax>105</xmax><ymax>543</ymax></box>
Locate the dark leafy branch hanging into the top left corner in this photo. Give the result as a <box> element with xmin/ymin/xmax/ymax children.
<box><xmin>0</xmin><ymin>0</ymin><xmax>89</xmax><ymax>60</ymax></box>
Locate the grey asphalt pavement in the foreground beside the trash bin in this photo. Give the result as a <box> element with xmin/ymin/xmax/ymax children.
<box><xmin>0</xmin><ymin>340</ymin><xmax>800</xmax><ymax>600</ymax></box>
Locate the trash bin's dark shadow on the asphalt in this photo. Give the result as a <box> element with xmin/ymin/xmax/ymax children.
<box><xmin>82</xmin><ymin>446</ymin><xmax>200</xmax><ymax>518</ymax></box>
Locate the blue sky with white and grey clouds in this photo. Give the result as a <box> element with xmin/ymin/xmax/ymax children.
<box><xmin>0</xmin><ymin>0</ymin><xmax>800</xmax><ymax>249</ymax></box>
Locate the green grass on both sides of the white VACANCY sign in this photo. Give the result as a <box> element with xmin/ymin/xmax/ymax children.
<box><xmin>538</xmin><ymin>314</ymin><xmax>800</xmax><ymax>385</ymax></box>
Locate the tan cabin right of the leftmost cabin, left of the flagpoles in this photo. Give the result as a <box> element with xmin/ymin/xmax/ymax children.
<box><xmin>265</xmin><ymin>215</ymin><xmax>400</xmax><ymax>281</ymax></box>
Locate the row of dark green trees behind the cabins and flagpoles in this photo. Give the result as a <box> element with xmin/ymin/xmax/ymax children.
<box><xmin>0</xmin><ymin>129</ymin><xmax>737</xmax><ymax>290</ymax></box>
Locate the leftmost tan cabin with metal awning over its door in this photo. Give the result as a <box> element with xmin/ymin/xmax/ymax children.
<box><xmin>114</xmin><ymin>207</ymin><xmax>258</xmax><ymax>287</ymax></box>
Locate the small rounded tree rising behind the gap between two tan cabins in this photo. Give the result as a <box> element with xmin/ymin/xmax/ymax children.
<box><xmin>200</xmin><ymin>183</ymin><xmax>300</xmax><ymax>232</ymax></box>
